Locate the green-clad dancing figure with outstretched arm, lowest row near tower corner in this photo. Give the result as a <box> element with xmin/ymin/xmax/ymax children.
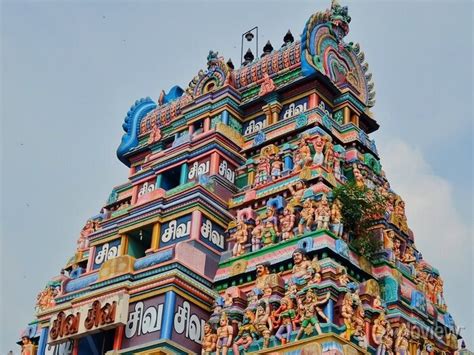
<box><xmin>295</xmin><ymin>289</ymin><xmax>331</xmax><ymax>340</ymax></box>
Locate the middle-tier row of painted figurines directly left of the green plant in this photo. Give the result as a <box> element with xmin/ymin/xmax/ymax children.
<box><xmin>228</xmin><ymin>191</ymin><xmax>343</xmax><ymax>256</ymax></box>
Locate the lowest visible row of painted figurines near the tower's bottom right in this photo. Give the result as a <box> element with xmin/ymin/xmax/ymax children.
<box><xmin>202</xmin><ymin>284</ymin><xmax>409</xmax><ymax>355</ymax></box>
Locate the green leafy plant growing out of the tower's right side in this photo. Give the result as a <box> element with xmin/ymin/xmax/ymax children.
<box><xmin>333</xmin><ymin>181</ymin><xmax>386</xmax><ymax>259</ymax></box>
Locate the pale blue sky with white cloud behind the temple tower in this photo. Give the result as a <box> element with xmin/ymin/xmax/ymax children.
<box><xmin>0</xmin><ymin>0</ymin><xmax>474</xmax><ymax>354</ymax></box>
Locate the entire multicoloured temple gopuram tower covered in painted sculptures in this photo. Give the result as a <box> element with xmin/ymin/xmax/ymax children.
<box><xmin>19</xmin><ymin>1</ymin><xmax>458</xmax><ymax>355</ymax></box>
